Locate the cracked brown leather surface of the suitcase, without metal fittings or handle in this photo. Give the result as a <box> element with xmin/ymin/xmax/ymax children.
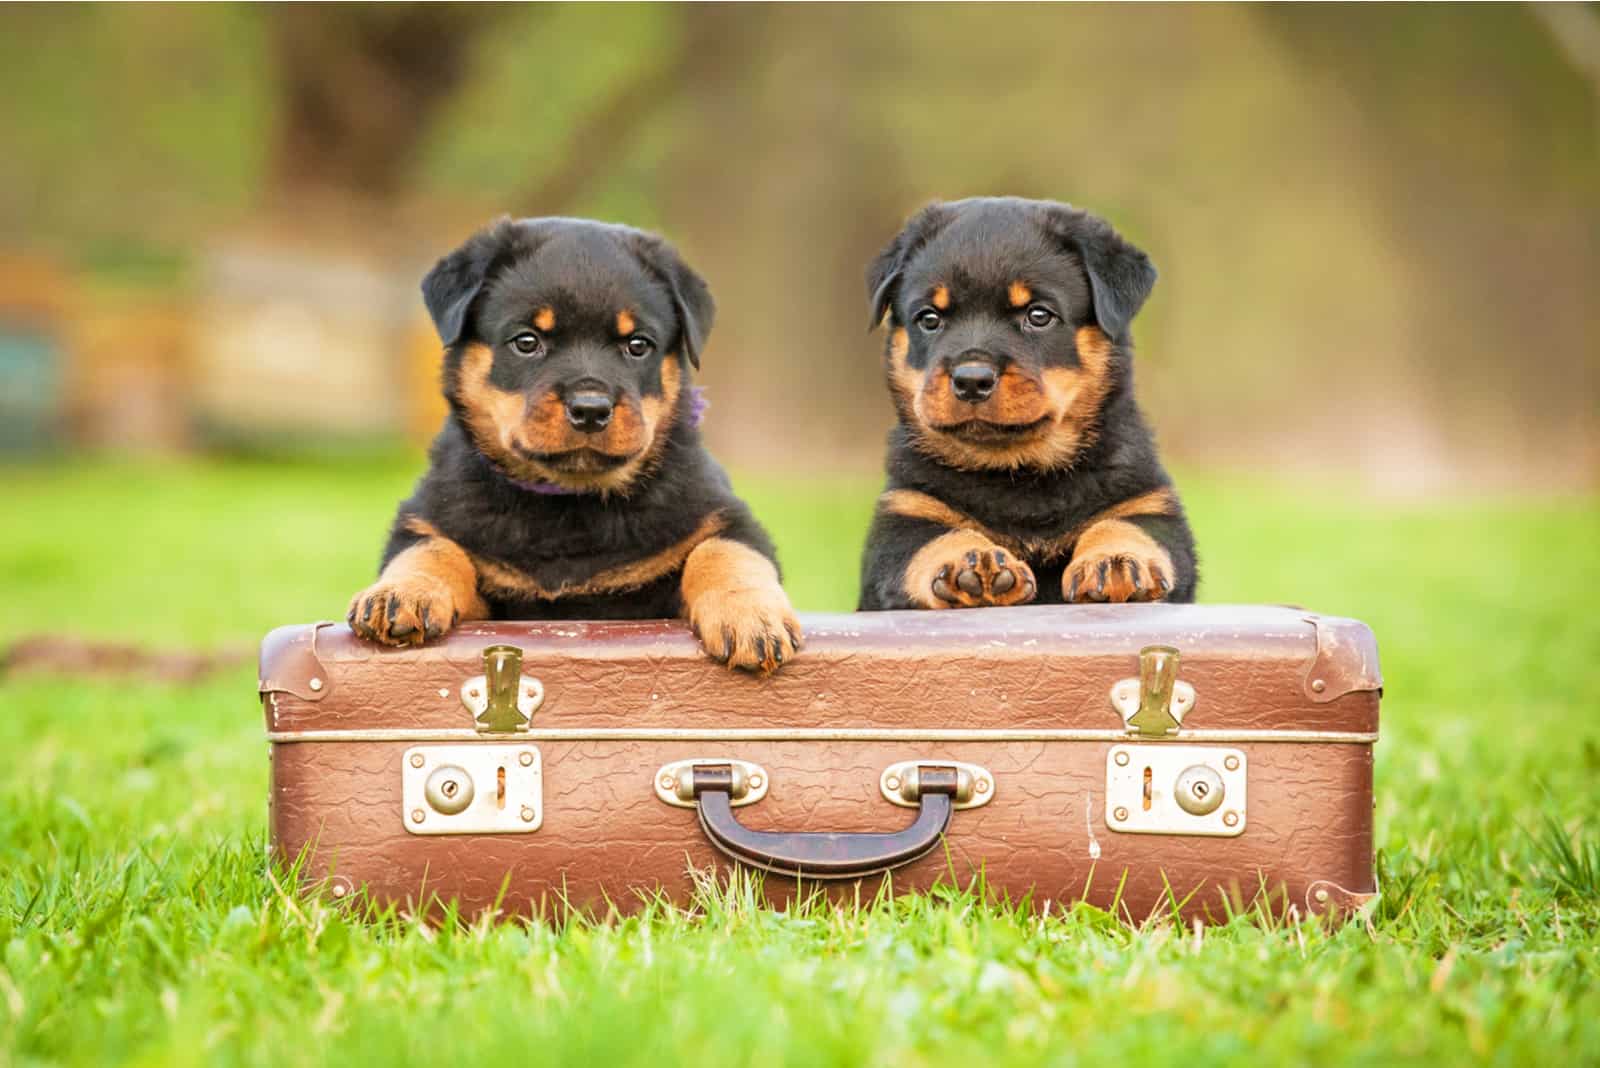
<box><xmin>262</xmin><ymin>606</ymin><xmax>1378</xmax><ymax>919</ymax></box>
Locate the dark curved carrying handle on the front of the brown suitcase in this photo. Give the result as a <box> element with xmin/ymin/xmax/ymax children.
<box><xmin>690</xmin><ymin>764</ymin><xmax>960</xmax><ymax>879</ymax></box>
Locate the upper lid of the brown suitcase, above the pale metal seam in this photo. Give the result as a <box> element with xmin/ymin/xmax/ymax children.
<box><xmin>259</xmin><ymin>604</ymin><xmax>1382</xmax><ymax>742</ymax></box>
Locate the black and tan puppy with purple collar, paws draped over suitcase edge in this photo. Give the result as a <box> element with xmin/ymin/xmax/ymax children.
<box><xmin>349</xmin><ymin>219</ymin><xmax>800</xmax><ymax>671</ymax></box>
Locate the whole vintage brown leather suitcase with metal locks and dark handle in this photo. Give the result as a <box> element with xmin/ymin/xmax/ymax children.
<box><xmin>261</xmin><ymin>604</ymin><xmax>1382</xmax><ymax>921</ymax></box>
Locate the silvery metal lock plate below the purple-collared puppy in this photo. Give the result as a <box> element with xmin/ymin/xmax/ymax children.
<box><xmin>400</xmin><ymin>742</ymin><xmax>544</xmax><ymax>835</ymax></box>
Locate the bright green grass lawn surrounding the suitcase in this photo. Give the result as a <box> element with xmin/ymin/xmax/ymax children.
<box><xmin>0</xmin><ymin>456</ymin><xmax>1600</xmax><ymax>1066</ymax></box>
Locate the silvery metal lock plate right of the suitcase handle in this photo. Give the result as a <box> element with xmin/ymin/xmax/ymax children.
<box><xmin>1106</xmin><ymin>742</ymin><xmax>1245</xmax><ymax>838</ymax></box>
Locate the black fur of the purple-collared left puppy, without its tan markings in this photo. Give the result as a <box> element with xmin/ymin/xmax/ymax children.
<box><xmin>382</xmin><ymin>219</ymin><xmax>776</xmax><ymax>619</ymax></box>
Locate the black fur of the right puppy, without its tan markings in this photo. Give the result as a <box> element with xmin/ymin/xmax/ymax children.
<box><xmin>859</xmin><ymin>198</ymin><xmax>1197</xmax><ymax>611</ymax></box>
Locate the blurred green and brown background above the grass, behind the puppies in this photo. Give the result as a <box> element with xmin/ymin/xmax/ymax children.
<box><xmin>0</xmin><ymin>5</ymin><xmax>1600</xmax><ymax>496</ymax></box>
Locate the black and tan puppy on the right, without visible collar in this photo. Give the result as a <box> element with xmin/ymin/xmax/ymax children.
<box><xmin>861</xmin><ymin>198</ymin><xmax>1195</xmax><ymax>611</ymax></box>
